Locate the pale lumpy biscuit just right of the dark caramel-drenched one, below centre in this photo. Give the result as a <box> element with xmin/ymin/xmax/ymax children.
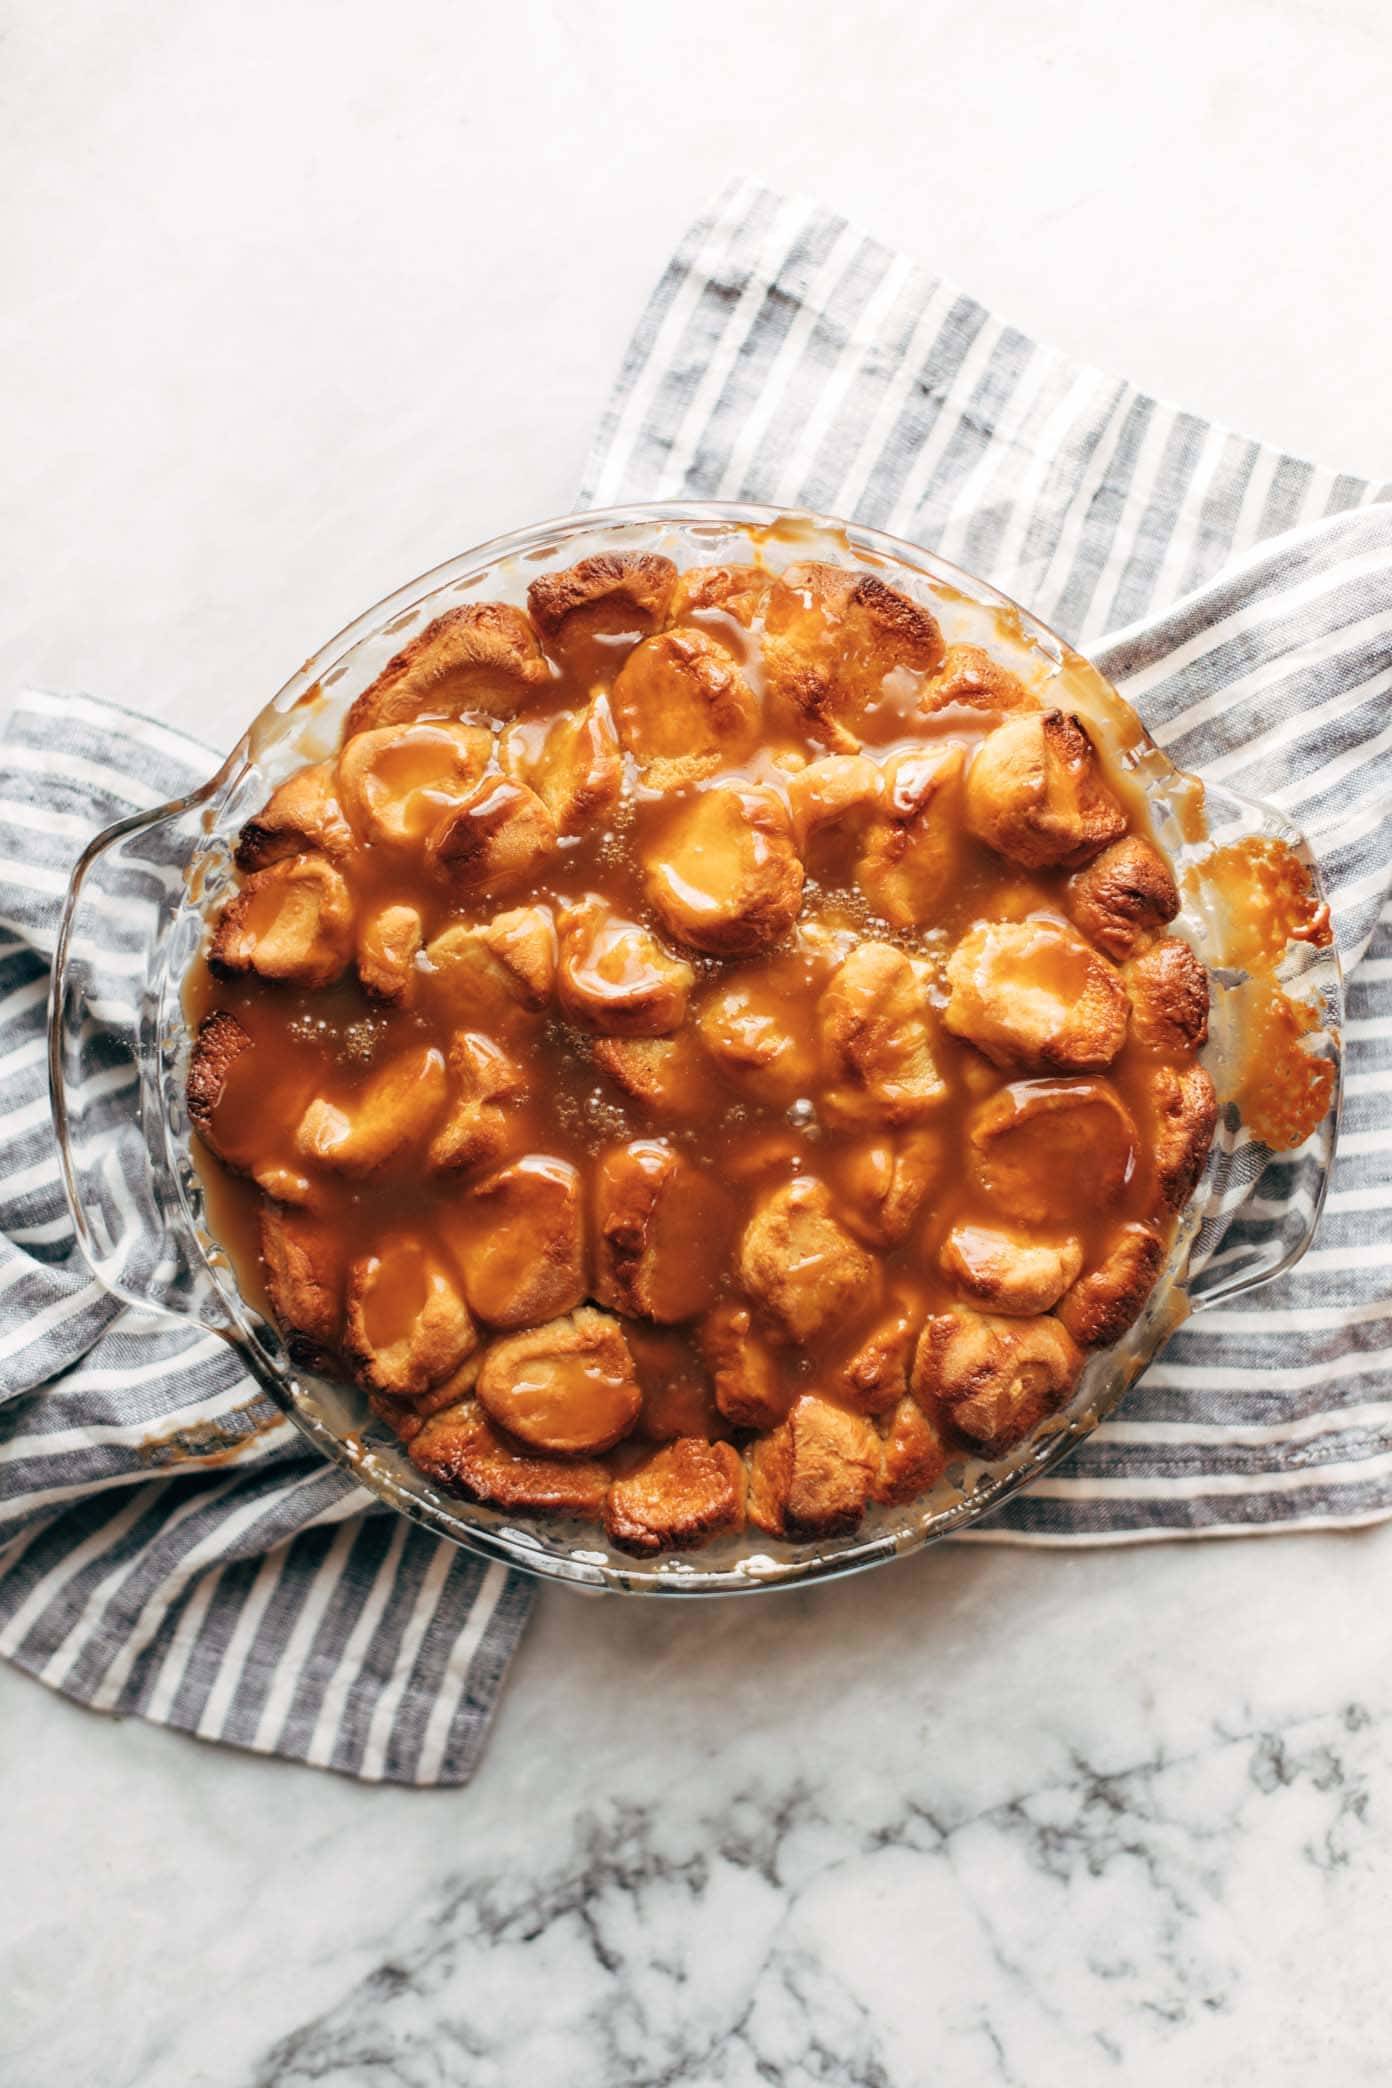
<box><xmin>737</xmin><ymin>1176</ymin><xmax>881</xmax><ymax>1343</ymax></box>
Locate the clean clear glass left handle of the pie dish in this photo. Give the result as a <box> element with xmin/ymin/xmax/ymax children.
<box><xmin>48</xmin><ymin>779</ymin><xmax>232</xmax><ymax>1334</ymax></box>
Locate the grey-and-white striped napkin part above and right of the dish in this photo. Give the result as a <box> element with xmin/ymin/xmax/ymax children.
<box><xmin>584</xmin><ymin>182</ymin><xmax>1392</xmax><ymax>1543</ymax></box>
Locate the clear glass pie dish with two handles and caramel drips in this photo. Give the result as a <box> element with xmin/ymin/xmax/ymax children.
<box><xmin>50</xmin><ymin>505</ymin><xmax>1342</xmax><ymax>1595</ymax></box>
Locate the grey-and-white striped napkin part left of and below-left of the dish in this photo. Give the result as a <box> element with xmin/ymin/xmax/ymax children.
<box><xmin>0</xmin><ymin>693</ymin><xmax>530</xmax><ymax>1783</ymax></box>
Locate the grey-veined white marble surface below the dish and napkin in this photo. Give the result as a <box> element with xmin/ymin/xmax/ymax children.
<box><xmin>0</xmin><ymin>1531</ymin><xmax>1392</xmax><ymax>2088</ymax></box>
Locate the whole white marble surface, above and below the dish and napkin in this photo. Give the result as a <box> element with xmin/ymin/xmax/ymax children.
<box><xmin>0</xmin><ymin>0</ymin><xmax>1392</xmax><ymax>2088</ymax></box>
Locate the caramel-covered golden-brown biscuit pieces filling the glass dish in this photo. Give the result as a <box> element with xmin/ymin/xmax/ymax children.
<box><xmin>186</xmin><ymin>560</ymin><xmax>1213</xmax><ymax>1551</ymax></box>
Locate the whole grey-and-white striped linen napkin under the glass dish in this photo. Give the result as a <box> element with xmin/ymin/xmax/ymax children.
<box><xmin>0</xmin><ymin>184</ymin><xmax>1392</xmax><ymax>1783</ymax></box>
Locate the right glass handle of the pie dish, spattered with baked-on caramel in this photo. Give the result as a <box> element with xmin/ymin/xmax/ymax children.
<box><xmin>1183</xmin><ymin>779</ymin><xmax>1344</xmax><ymax>1313</ymax></box>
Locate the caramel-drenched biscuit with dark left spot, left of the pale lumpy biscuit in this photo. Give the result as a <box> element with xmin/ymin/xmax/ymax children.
<box><xmin>595</xmin><ymin>1138</ymin><xmax>733</xmax><ymax>1324</ymax></box>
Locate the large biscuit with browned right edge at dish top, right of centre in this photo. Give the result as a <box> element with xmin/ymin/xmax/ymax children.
<box><xmin>764</xmin><ymin>562</ymin><xmax>943</xmax><ymax>754</ymax></box>
